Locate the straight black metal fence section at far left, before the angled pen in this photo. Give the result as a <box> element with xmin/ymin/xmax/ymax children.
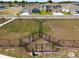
<box><xmin>0</xmin><ymin>39</ymin><xmax>19</xmax><ymax>47</ymax></box>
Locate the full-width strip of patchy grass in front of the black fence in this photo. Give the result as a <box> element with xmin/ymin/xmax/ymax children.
<box><xmin>0</xmin><ymin>48</ymin><xmax>79</xmax><ymax>58</ymax></box>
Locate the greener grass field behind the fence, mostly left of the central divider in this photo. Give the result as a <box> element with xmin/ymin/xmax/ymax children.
<box><xmin>0</xmin><ymin>19</ymin><xmax>50</xmax><ymax>39</ymax></box>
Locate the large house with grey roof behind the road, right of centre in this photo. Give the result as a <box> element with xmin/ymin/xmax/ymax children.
<box><xmin>41</xmin><ymin>3</ymin><xmax>61</xmax><ymax>12</ymax></box>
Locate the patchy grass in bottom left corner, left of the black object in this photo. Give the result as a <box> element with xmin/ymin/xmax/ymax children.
<box><xmin>0</xmin><ymin>48</ymin><xmax>32</xmax><ymax>58</ymax></box>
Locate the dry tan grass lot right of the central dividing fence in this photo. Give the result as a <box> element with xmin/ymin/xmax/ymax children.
<box><xmin>44</xmin><ymin>19</ymin><xmax>79</xmax><ymax>40</ymax></box>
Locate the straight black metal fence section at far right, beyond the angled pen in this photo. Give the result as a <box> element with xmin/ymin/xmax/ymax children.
<box><xmin>58</xmin><ymin>40</ymin><xmax>79</xmax><ymax>48</ymax></box>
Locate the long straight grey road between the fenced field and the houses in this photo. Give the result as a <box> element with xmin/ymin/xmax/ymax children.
<box><xmin>0</xmin><ymin>15</ymin><xmax>79</xmax><ymax>20</ymax></box>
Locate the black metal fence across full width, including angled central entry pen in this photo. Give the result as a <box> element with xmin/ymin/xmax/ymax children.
<box><xmin>0</xmin><ymin>33</ymin><xmax>79</xmax><ymax>52</ymax></box>
